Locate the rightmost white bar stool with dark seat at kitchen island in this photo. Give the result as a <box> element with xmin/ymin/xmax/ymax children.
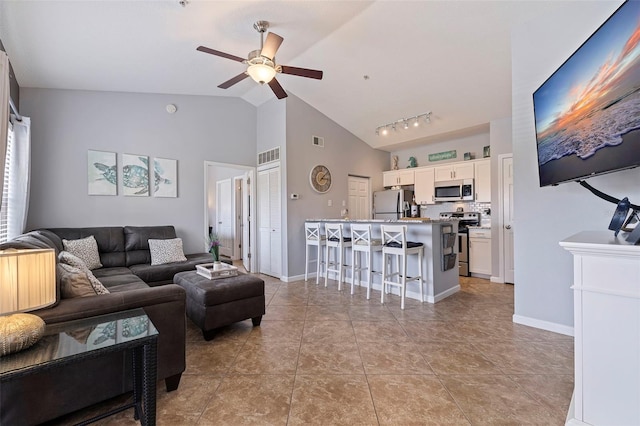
<box><xmin>380</xmin><ymin>225</ymin><xmax>424</xmax><ymax>309</ymax></box>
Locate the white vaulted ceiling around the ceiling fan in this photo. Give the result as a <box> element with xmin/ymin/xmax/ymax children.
<box><xmin>0</xmin><ymin>0</ymin><xmax>552</xmax><ymax>151</ymax></box>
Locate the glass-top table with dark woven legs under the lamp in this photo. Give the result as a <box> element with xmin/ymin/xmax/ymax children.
<box><xmin>0</xmin><ymin>309</ymin><xmax>158</xmax><ymax>425</ymax></box>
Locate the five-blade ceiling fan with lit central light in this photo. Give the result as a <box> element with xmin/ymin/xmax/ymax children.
<box><xmin>197</xmin><ymin>21</ymin><xmax>322</xmax><ymax>99</ymax></box>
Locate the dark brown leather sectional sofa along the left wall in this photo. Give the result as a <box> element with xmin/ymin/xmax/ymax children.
<box><xmin>0</xmin><ymin>226</ymin><xmax>211</xmax><ymax>425</ymax></box>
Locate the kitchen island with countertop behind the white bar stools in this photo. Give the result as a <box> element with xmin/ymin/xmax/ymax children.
<box><xmin>307</xmin><ymin>218</ymin><xmax>460</xmax><ymax>303</ymax></box>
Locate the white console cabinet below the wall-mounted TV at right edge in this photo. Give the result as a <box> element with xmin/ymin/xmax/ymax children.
<box><xmin>560</xmin><ymin>231</ymin><xmax>640</xmax><ymax>425</ymax></box>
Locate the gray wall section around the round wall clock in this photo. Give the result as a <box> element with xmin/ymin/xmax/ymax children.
<box><xmin>284</xmin><ymin>95</ymin><xmax>390</xmax><ymax>277</ymax></box>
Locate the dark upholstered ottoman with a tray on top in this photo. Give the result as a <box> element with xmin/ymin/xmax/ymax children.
<box><xmin>173</xmin><ymin>271</ymin><xmax>265</xmax><ymax>340</ymax></box>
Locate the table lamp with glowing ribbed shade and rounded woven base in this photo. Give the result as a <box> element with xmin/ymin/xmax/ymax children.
<box><xmin>0</xmin><ymin>249</ymin><xmax>56</xmax><ymax>356</ymax></box>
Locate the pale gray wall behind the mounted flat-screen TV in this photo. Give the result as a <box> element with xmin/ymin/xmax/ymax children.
<box><xmin>512</xmin><ymin>2</ymin><xmax>640</xmax><ymax>332</ymax></box>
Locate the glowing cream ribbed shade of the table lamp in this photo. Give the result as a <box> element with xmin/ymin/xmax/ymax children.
<box><xmin>0</xmin><ymin>249</ymin><xmax>56</xmax><ymax>315</ymax></box>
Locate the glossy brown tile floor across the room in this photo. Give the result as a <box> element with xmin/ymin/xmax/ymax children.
<box><xmin>48</xmin><ymin>276</ymin><xmax>573</xmax><ymax>425</ymax></box>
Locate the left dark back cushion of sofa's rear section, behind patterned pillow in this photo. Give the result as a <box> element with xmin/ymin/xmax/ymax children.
<box><xmin>47</xmin><ymin>226</ymin><xmax>126</xmax><ymax>268</ymax></box>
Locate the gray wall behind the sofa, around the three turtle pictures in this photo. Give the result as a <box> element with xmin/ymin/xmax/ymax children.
<box><xmin>21</xmin><ymin>88</ymin><xmax>256</xmax><ymax>252</ymax></box>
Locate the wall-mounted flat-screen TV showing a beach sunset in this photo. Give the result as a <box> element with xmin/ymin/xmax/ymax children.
<box><xmin>533</xmin><ymin>0</ymin><xmax>640</xmax><ymax>186</ymax></box>
